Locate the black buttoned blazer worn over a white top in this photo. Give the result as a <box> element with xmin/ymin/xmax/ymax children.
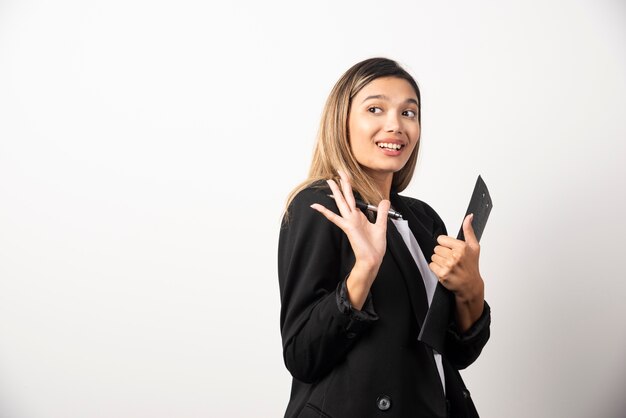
<box><xmin>278</xmin><ymin>184</ymin><xmax>490</xmax><ymax>418</ymax></box>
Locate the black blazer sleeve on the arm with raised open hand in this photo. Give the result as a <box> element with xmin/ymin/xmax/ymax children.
<box><xmin>278</xmin><ymin>188</ymin><xmax>377</xmax><ymax>383</ymax></box>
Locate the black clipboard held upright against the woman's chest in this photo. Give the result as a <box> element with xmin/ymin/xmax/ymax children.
<box><xmin>417</xmin><ymin>175</ymin><xmax>493</xmax><ymax>353</ymax></box>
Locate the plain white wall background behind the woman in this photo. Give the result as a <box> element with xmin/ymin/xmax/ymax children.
<box><xmin>0</xmin><ymin>0</ymin><xmax>626</xmax><ymax>418</ymax></box>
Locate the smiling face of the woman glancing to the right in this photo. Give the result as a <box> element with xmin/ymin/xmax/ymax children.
<box><xmin>348</xmin><ymin>77</ymin><xmax>420</xmax><ymax>184</ymax></box>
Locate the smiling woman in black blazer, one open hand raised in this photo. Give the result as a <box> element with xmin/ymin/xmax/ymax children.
<box><xmin>278</xmin><ymin>58</ymin><xmax>490</xmax><ymax>418</ymax></box>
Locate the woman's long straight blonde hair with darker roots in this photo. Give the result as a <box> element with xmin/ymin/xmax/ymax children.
<box><xmin>285</xmin><ymin>58</ymin><xmax>421</xmax><ymax>214</ymax></box>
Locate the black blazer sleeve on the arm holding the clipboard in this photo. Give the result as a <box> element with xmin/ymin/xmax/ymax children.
<box><xmin>416</xmin><ymin>198</ymin><xmax>491</xmax><ymax>370</ymax></box>
